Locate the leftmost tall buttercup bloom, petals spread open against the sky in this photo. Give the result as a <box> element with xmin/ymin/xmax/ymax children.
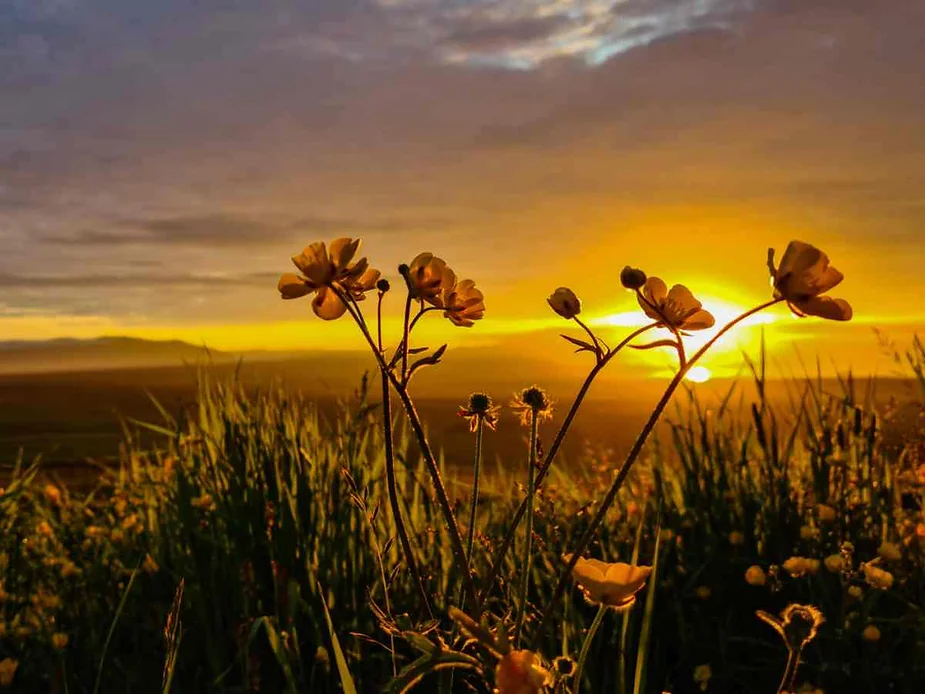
<box><xmin>277</xmin><ymin>238</ymin><xmax>379</xmax><ymax>320</ymax></box>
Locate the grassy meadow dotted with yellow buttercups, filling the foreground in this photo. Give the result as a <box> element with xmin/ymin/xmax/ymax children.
<box><xmin>0</xmin><ymin>239</ymin><xmax>925</xmax><ymax>694</ymax></box>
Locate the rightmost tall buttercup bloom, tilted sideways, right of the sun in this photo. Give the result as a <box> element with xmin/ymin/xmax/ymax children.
<box><xmin>768</xmin><ymin>241</ymin><xmax>852</xmax><ymax>320</ymax></box>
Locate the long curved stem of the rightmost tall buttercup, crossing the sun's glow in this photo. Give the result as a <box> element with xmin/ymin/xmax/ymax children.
<box><xmin>533</xmin><ymin>299</ymin><xmax>782</xmax><ymax>645</ymax></box>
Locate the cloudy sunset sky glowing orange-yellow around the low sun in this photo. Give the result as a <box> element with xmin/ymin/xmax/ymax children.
<box><xmin>0</xmin><ymin>0</ymin><xmax>925</xmax><ymax>380</ymax></box>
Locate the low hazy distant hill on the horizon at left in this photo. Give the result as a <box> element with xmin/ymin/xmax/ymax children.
<box><xmin>0</xmin><ymin>337</ymin><xmax>238</xmax><ymax>374</ymax></box>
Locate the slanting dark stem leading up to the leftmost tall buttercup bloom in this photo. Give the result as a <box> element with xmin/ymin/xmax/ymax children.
<box><xmin>335</xmin><ymin>289</ymin><xmax>481</xmax><ymax>610</ymax></box>
